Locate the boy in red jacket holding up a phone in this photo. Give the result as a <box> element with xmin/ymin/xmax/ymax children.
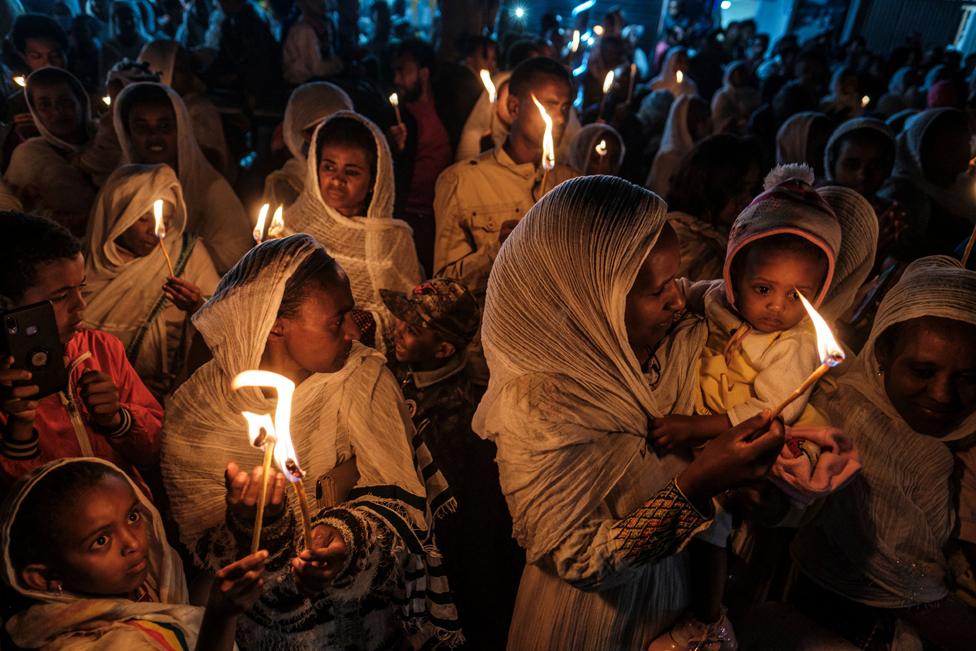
<box><xmin>0</xmin><ymin>212</ymin><xmax>163</xmax><ymax>494</ymax></box>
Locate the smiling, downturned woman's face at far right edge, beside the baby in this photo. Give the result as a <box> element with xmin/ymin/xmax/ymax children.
<box><xmin>876</xmin><ymin>317</ymin><xmax>976</xmax><ymax>437</ymax></box>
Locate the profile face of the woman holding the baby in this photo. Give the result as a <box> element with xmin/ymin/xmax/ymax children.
<box><xmin>624</xmin><ymin>225</ymin><xmax>685</xmax><ymax>367</ymax></box>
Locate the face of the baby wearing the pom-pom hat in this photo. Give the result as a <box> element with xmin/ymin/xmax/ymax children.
<box><xmin>735</xmin><ymin>247</ymin><xmax>827</xmax><ymax>332</ymax></box>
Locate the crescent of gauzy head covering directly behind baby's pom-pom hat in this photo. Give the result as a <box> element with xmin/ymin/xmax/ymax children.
<box><xmin>817</xmin><ymin>185</ymin><xmax>878</xmax><ymax>321</ymax></box>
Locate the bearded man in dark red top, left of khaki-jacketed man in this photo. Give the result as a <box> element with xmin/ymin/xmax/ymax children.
<box><xmin>390</xmin><ymin>38</ymin><xmax>458</xmax><ymax>275</ymax></box>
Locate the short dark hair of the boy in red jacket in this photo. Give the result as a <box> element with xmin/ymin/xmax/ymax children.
<box><xmin>0</xmin><ymin>211</ymin><xmax>81</xmax><ymax>304</ymax></box>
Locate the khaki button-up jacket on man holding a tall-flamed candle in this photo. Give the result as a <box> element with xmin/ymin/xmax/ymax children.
<box><xmin>434</xmin><ymin>147</ymin><xmax>579</xmax><ymax>294</ymax></box>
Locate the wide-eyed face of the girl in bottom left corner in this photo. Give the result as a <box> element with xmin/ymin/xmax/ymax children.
<box><xmin>40</xmin><ymin>475</ymin><xmax>149</xmax><ymax>596</ymax></box>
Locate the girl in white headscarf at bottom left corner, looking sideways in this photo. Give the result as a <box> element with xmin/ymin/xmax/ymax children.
<box><xmin>0</xmin><ymin>458</ymin><xmax>266</xmax><ymax>651</ymax></box>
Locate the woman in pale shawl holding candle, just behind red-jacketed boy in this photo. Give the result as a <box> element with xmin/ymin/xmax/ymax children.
<box><xmin>83</xmin><ymin>165</ymin><xmax>220</xmax><ymax>398</ymax></box>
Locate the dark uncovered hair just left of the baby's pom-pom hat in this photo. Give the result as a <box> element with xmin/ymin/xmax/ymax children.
<box><xmin>667</xmin><ymin>133</ymin><xmax>761</xmax><ymax>224</ymax></box>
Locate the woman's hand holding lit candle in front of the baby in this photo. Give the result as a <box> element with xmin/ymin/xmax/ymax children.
<box><xmin>678</xmin><ymin>410</ymin><xmax>786</xmax><ymax>510</ymax></box>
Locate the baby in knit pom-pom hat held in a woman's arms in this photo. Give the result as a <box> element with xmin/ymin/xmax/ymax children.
<box><xmin>651</xmin><ymin>166</ymin><xmax>857</xmax><ymax>649</ymax></box>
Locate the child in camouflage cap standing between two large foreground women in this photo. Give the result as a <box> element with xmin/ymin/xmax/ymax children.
<box><xmin>381</xmin><ymin>278</ymin><xmax>525</xmax><ymax>649</ymax></box>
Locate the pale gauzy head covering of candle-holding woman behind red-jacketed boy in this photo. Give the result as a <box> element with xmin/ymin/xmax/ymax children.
<box><xmin>83</xmin><ymin>165</ymin><xmax>186</xmax><ymax>354</ymax></box>
